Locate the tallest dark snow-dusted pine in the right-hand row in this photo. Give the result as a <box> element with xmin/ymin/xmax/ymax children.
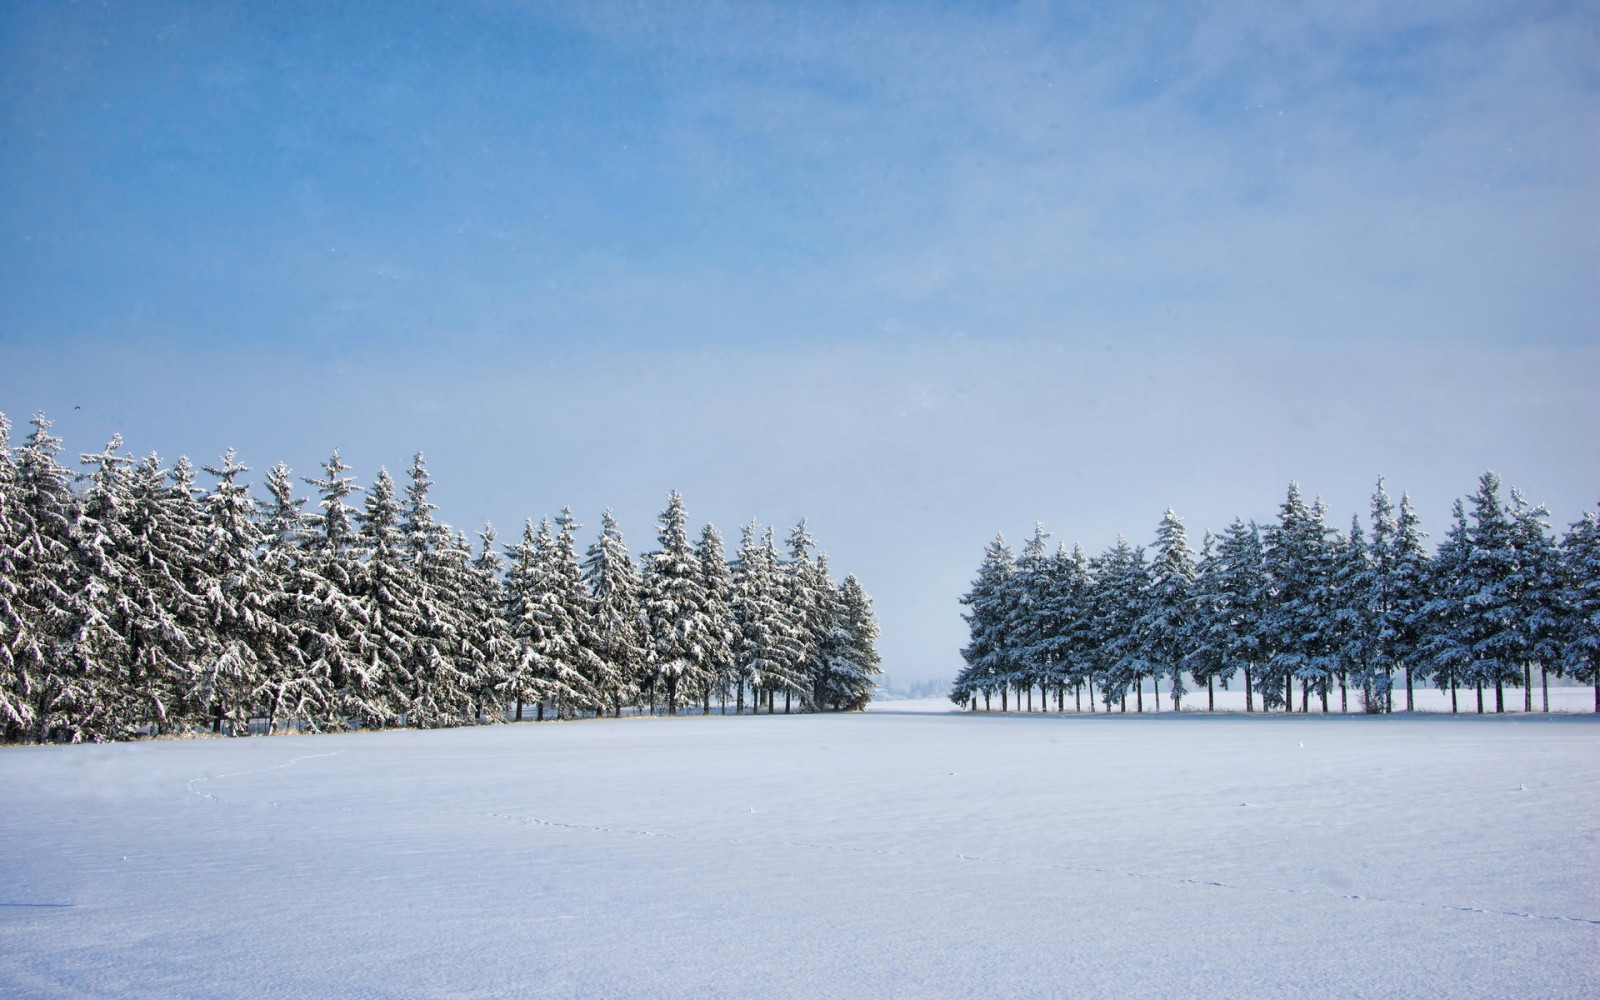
<box><xmin>1466</xmin><ymin>472</ymin><xmax>1522</xmax><ymax>714</ymax></box>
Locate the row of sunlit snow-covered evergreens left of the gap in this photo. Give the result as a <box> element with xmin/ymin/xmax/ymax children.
<box><xmin>0</xmin><ymin>414</ymin><xmax>878</xmax><ymax>742</ymax></box>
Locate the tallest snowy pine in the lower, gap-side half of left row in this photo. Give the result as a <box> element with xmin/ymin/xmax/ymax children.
<box><xmin>642</xmin><ymin>490</ymin><xmax>706</xmax><ymax>715</ymax></box>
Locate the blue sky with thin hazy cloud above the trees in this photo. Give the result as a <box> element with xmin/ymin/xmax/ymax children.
<box><xmin>0</xmin><ymin>2</ymin><xmax>1600</xmax><ymax>678</ymax></box>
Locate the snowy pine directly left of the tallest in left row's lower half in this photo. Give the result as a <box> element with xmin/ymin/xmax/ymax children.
<box><xmin>582</xmin><ymin>507</ymin><xmax>648</xmax><ymax>715</ymax></box>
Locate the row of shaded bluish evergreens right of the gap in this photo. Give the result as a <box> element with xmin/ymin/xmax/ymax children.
<box><xmin>950</xmin><ymin>472</ymin><xmax>1600</xmax><ymax>712</ymax></box>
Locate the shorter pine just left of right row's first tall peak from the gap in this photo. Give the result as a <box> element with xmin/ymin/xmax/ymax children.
<box><xmin>1090</xmin><ymin>536</ymin><xmax>1154</xmax><ymax>712</ymax></box>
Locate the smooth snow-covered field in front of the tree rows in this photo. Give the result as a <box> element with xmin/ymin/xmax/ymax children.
<box><xmin>0</xmin><ymin>702</ymin><xmax>1600</xmax><ymax>1000</ymax></box>
